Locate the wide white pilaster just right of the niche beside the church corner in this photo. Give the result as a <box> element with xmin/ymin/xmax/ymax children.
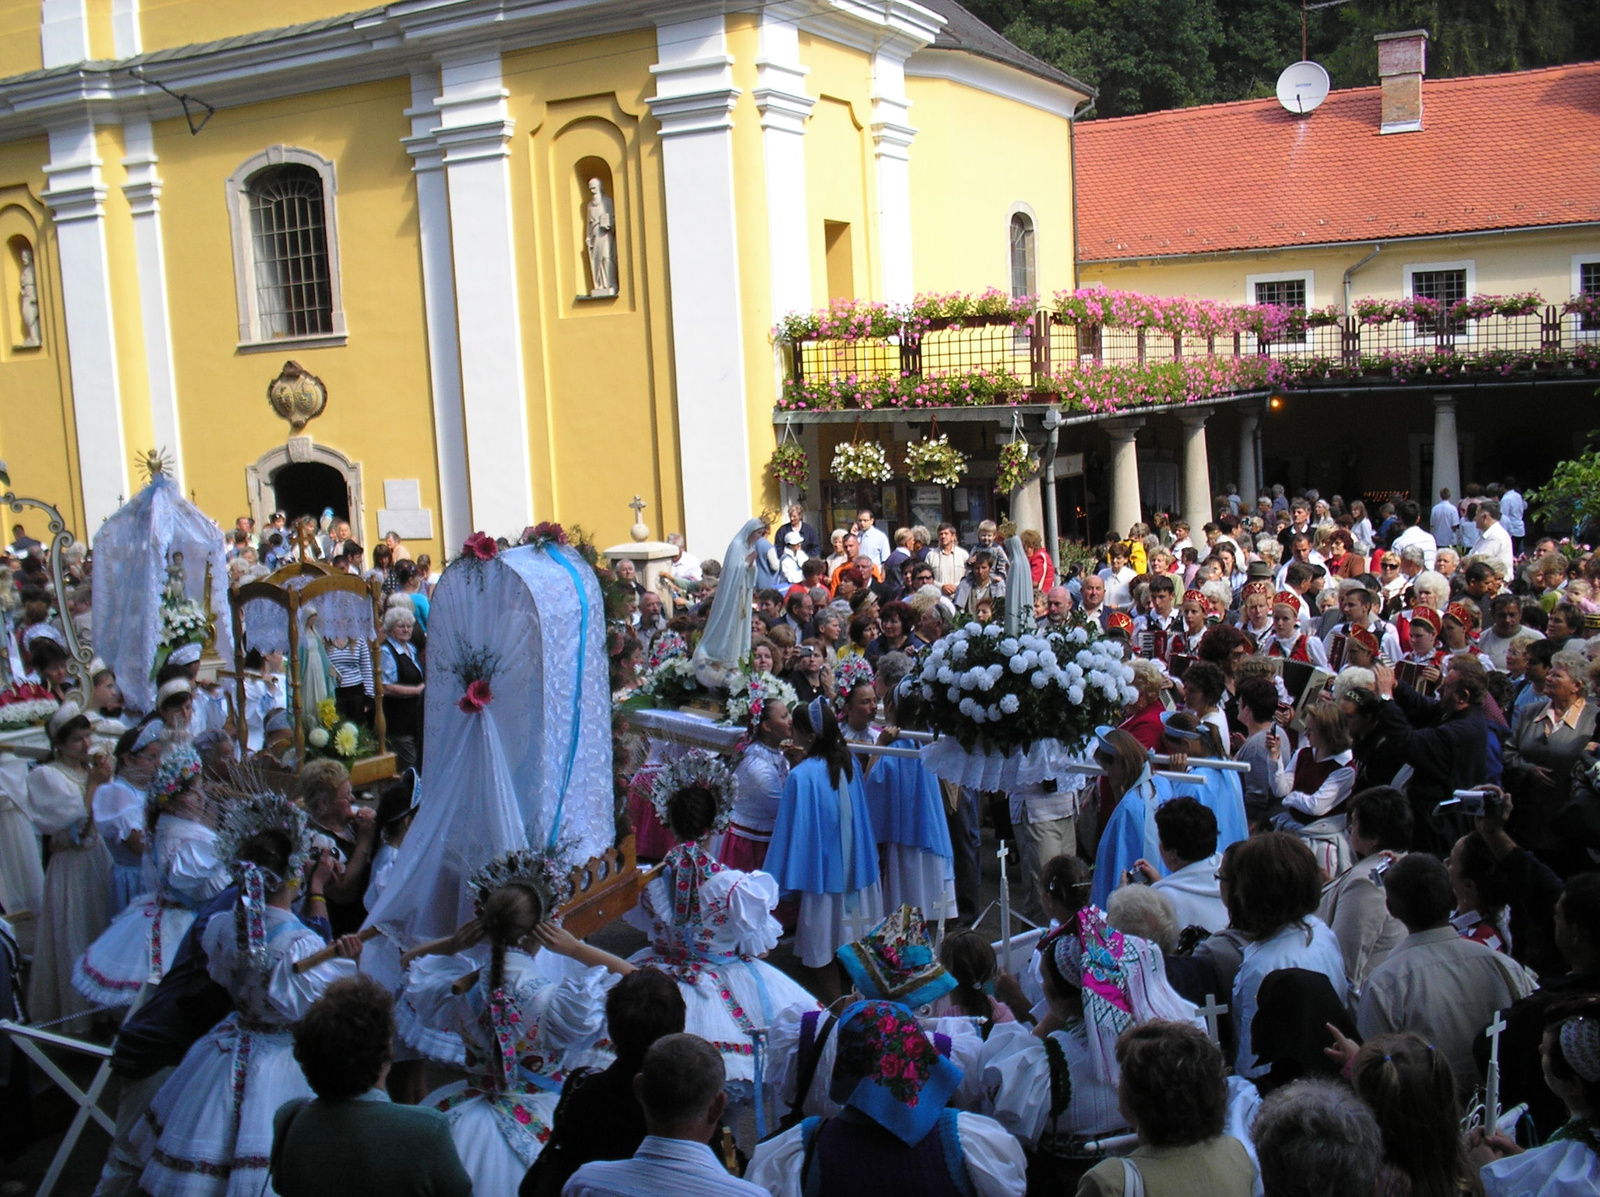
<box><xmin>650</xmin><ymin>13</ymin><xmax>752</xmax><ymax>557</ymax></box>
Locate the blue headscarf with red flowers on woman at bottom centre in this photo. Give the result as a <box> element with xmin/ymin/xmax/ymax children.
<box><xmin>829</xmin><ymin>1002</ymin><xmax>962</xmax><ymax>1146</ymax></box>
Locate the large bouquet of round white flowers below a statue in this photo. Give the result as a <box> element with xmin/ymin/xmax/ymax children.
<box><xmin>917</xmin><ymin>623</ymin><xmax>1138</xmax><ymax>754</ymax></box>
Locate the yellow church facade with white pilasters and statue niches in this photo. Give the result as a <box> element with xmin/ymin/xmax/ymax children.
<box><xmin>0</xmin><ymin>0</ymin><xmax>1091</xmax><ymax>555</ymax></box>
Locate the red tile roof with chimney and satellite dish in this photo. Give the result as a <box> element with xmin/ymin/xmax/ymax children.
<box><xmin>1077</xmin><ymin>62</ymin><xmax>1600</xmax><ymax>262</ymax></box>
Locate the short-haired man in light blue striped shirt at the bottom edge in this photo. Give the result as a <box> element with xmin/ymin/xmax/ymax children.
<box><xmin>562</xmin><ymin>1035</ymin><xmax>768</xmax><ymax>1197</ymax></box>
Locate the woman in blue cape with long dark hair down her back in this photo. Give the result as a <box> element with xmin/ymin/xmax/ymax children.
<box><xmin>766</xmin><ymin>695</ymin><xmax>883</xmax><ymax>999</ymax></box>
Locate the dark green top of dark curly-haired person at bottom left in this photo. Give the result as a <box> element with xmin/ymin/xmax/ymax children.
<box><xmin>272</xmin><ymin>1090</ymin><xmax>472</xmax><ymax>1197</ymax></box>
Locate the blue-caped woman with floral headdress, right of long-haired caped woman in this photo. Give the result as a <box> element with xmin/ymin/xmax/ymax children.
<box><xmin>862</xmin><ymin>687</ymin><xmax>955</xmax><ymax>920</ymax></box>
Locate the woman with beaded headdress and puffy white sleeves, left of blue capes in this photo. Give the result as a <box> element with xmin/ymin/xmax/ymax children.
<box><xmin>627</xmin><ymin>749</ymin><xmax>818</xmax><ymax>1099</ymax></box>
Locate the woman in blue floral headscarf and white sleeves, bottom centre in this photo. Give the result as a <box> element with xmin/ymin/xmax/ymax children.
<box><xmin>746</xmin><ymin>1002</ymin><xmax>1027</xmax><ymax>1197</ymax></box>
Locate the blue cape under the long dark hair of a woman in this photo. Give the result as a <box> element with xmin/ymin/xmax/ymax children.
<box><xmin>763</xmin><ymin>757</ymin><xmax>878</xmax><ymax>893</ymax></box>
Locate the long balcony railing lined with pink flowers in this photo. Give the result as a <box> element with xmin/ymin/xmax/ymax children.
<box><xmin>774</xmin><ymin>291</ymin><xmax>1600</xmax><ymax>411</ymax></box>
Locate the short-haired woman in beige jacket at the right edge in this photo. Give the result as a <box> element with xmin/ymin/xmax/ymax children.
<box><xmin>1504</xmin><ymin>650</ymin><xmax>1597</xmax><ymax>855</ymax></box>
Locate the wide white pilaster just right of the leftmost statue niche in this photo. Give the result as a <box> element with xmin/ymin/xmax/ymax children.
<box><xmin>43</xmin><ymin>120</ymin><xmax>130</xmax><ymax>524</ymax></box>
